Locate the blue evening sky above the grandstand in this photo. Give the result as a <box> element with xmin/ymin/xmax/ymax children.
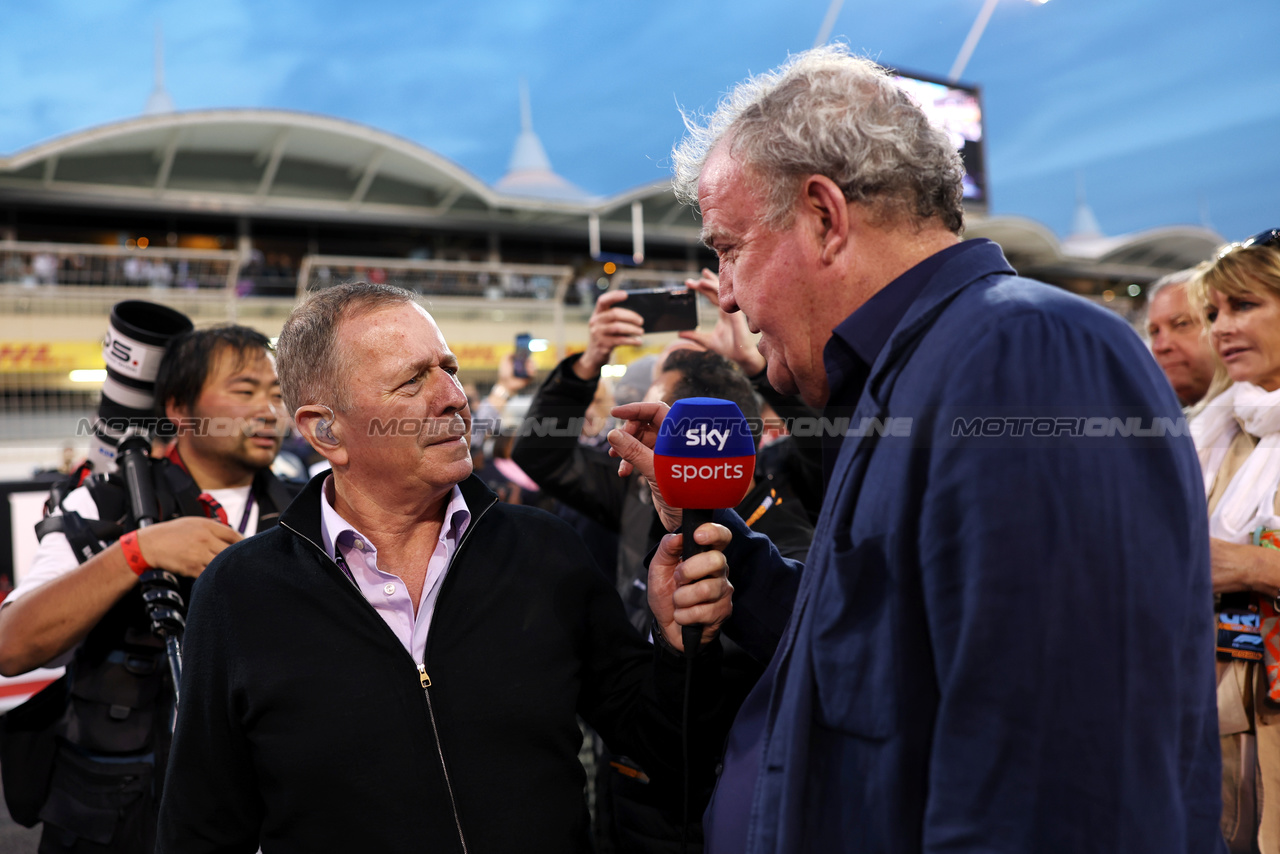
<box><xmin>0</xmin><ymin>0</ymin><xmax>1280</xmax><ymax>239</ymax></box>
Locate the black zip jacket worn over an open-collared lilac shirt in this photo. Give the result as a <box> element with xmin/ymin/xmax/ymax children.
<box><xmin>156</xmin><ymin>475</ymin><xmax>723</xmax><ymax>854</ymax></box>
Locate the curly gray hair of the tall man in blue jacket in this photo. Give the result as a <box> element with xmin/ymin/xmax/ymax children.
<box><xmin>672</xmin><ymin>44</ymin><xmax>964</xmax><ymax>234</ymax></box>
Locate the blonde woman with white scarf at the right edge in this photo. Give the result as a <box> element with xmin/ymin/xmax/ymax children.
<box><xmin>1190</xmin><ymin>229</ymin><xmax>1280</xmax><ymax>854</ymax></box>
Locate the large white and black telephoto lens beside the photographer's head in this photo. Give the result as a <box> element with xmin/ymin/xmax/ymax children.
<box><xmin>88</xmin><ymin>300</ymin><xmax>193</xmax><ymax>474</ymax></box>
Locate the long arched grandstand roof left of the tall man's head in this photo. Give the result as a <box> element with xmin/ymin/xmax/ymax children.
<box><xmin>0</xmin><ymin>110</ymin><xmax>650</xmax><ymax>231</ymax></box>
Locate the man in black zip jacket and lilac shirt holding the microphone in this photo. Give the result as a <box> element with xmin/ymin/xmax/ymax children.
<box><xmin>157</xmin><ymin>283</ymin><xmax>731</xmax><ymax>854</ymax></box>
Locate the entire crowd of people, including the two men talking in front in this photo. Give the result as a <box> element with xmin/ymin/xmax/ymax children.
<box><xmin>0</xmin><ymin>46</ymin><xmax>1280</xmax><ymax>854</ymax></box>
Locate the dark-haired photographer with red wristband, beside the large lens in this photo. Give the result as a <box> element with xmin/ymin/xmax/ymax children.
<box><xmin>0</xmin><ymin>325</ymin><xmax>292</xmax><ymax>851</ymax></box>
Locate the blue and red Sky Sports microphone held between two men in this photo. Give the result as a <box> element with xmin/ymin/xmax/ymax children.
<box><xmin>653</xmin><ymin>397</ymin><xmax>755</xmax><ymax>656</ymax></box>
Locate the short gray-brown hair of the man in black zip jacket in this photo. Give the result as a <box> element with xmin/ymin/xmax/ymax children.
<box><xmin>275</xmin><ymin>282</ymin><xmax>413</xmax><ymax>415</ymax></box>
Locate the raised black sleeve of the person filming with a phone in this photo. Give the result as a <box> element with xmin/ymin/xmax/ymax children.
<box><xmin>511</xmin><ymin>353</ymin><xmax>627</xmax><ymax>531</ymax></box>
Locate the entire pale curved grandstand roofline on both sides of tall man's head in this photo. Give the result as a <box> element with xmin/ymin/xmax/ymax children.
<box><xmin>0</xmin><ymin>109</ymin><xmax>1224</xmax><ymax>282</ymax></box>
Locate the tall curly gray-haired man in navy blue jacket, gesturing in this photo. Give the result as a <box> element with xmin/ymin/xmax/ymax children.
<box><xmin>611</xmin><ymin>46</ymin><xmax>1221</xmax><ymax>854</ymax></box>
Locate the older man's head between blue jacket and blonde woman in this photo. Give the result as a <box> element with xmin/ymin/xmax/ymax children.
<box><xmin>1147</xmin><ymin>270</ymin><xmax>1217</xmax><ymax>406</ymax></box>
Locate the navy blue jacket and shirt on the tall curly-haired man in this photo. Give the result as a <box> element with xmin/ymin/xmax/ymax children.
<box><xmin>705</xmin><ymin>241</ymin><xmax>1222</xmax><ymax>854</ymax></box>
